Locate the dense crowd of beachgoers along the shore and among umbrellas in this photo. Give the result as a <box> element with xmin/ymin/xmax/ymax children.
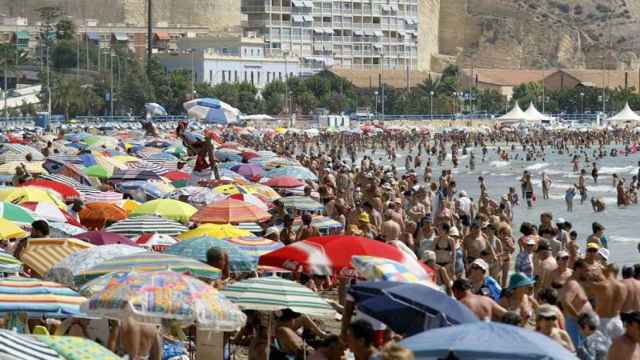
<box><xmin>1</xmin><ymin>124</ymin><xmax>640</xmax><ymax>360</ymax></box>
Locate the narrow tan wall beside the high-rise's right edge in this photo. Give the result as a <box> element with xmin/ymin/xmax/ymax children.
<box><xmin>417</xmin><ymin>0</ymin><xmax>440</xmax><ymax>71</ymax></box>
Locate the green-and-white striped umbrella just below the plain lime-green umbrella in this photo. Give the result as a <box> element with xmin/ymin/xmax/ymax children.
<box><xmin>105</xmin><ymin>215</ymin><xmax>187</xmax><ymax>237</ymax></box>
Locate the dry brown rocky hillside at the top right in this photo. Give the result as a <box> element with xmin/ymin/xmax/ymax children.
<box><xmin>440</xmin><ymin>0</ymin><xmax>640</xmax><ymax>69</ymax></box>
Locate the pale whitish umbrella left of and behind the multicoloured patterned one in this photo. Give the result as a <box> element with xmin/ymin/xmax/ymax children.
<box><xmin>44</xmin><ymin>244</ymin><xmax>147</xmax><ymax>287</ymax></box>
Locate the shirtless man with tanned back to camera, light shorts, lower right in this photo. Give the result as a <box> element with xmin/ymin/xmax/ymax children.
<box><xmin>586</xmin><ymin>264</ymin><xmax>627</xmax><ymax>339</ymax></box>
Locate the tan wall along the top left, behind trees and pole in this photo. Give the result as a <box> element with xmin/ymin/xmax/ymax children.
<box><xmin>0</xmin><ymin>0</ymin><xmax>241</xmax><ymax>32</ymax></box>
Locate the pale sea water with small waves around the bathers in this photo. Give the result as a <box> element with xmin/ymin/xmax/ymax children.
<box><xmin>360</xmin><ymin>146</ymin><xmax>640</xmax><ymax>265</ymax></box>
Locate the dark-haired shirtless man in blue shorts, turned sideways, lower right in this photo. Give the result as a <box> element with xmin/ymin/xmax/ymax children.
<box><xmin>560</xmin><ymin>259</ymin><xmax>593</xmax><ymax>347</ymax></box>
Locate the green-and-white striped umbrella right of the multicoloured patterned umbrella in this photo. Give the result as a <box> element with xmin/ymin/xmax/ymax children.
<box><xmin>222</xmin><ymin>276</ymin><xmax>335</xmax><ymax>318</ymax></box>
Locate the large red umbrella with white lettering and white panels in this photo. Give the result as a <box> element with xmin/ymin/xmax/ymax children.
<box><xmin>259</xmin><ymin>235</ymin><xmax>426</xmax><ymax>275</ymax></box>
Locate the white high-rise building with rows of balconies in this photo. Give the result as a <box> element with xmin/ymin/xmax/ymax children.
<box><xmin>242</xmin><ymin>0</ymin><xmax>418</xmax><ymax>70</ymax></box>
